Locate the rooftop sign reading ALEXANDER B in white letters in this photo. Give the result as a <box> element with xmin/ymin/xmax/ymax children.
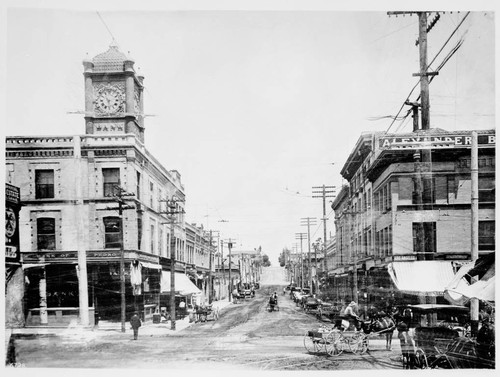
<box><xmin>378</xmin><ymin>133</ymin><xmax>495</xmax><ymax>149</ymax></box>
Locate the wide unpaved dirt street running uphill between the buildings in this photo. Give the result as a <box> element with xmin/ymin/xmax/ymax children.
<box><xmin>11</xmin><ymin>286</ymin><xmax>401</xmax><ymax>370</ymax></box>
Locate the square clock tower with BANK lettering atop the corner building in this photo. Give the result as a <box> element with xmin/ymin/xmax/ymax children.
<box><xmin>83</xmin><ymin>44</ymin><xmax>144</xmax><ymax>143</ymax></box>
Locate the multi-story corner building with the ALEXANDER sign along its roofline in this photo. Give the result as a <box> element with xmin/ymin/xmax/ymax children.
<box><xmin>329</xmin><ymin>129</ymin><xmax>495</xmax><ymax>310</ymax></box>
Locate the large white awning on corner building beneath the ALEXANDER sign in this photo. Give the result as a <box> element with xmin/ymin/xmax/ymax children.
<box><xmin>387</xmin><ymin>261</ymin><xmax>464</xmax><ymax>296</ymax></box>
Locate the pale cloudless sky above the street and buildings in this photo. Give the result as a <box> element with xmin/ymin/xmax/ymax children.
<box><xmin>1</xmin><ymin>0</ymin><xmax>498</xmax><ymax>265</ymax></box>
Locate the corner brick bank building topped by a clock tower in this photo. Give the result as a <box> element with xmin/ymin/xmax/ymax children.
<box><xmin>6</xmin><ymin>46</ymin><xmax>207</xmax><ymax>324</ymax></box>
